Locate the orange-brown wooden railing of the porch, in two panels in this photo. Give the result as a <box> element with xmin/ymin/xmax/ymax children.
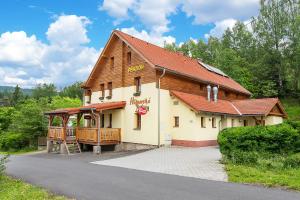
<box><xmin>76</xmin><ymin>128</ymin><xmax>121</xmax><ymax>144</ymax></box>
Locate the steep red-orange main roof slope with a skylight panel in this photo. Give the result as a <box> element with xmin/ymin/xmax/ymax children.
<box><xmin>114</xmin><ymin>30</ymin><xmax>251</xmax><ymax>95</ymax></box>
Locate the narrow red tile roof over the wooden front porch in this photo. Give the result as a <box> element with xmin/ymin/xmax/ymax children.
<box><xmin>45</xmin><ymin>101</ymin><xmax>126</xmax><ymax>115</ymax></box>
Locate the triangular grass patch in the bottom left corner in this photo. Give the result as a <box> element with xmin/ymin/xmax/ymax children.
<box><xmin>0</xmin><ymin>175</ymin><xmax>66</xmax><ymax>200</ymax></box>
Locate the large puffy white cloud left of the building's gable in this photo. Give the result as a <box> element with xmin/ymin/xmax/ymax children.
<box><xmin>0</xmin><ymin>15</ymin><xmax>99</xmax><ymax>87</ymax></box>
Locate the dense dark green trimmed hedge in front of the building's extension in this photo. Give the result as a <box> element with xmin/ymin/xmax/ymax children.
<box><xmin>218</xmin><ymin>123</ymin><xmax>300</xmax><ymax>157</ymax></box>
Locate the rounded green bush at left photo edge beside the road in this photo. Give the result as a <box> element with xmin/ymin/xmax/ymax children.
<box><xmin>0</xmin><ymin>132</ymin><xmax>29</xmax><ymax>151</ymax></box>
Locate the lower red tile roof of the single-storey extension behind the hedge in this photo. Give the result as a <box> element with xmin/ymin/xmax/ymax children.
<box><xmin>170</xmin><ymin>91</ymin><xmax>286</xmax><ymax>117</ymax></box>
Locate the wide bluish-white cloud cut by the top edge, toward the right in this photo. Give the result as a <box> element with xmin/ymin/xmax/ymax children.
<box><xmin>182</xmin><ymin>0</ymin><xmax>260</xmax><ymax>24</ymax></box>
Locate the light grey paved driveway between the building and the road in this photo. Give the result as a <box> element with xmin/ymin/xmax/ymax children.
<box><xmin>93</xmin><ymin>147</ymin><xmax>227</xmax><ymax>181</ymax></box>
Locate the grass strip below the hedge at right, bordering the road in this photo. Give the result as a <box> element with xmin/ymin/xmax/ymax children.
<box><xmin>226</xmin><ymin>163</ymin><xmax>300</xmax><ymax>191</ymax></box>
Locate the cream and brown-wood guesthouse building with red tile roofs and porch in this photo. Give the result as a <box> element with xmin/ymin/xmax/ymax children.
<box><xmin>47</xmin><ymin>30</ymin><xmax>287</xmax><ymax>152</ymax></box>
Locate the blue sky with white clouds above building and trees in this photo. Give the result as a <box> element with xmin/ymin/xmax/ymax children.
<box><xmin>0</xmin><ymin>0</ymin><xmax>259</xmax><ymax>88</ymax></box>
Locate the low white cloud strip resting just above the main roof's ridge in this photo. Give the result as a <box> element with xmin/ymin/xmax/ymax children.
<box><xmin>121</xmin><ymin>27</ymin><xmax>176</xmax><ymax>46</ymax></box>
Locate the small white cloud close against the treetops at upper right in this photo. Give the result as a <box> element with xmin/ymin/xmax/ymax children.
<box><xmin>204</xmin><ymin>19</ymin><xmax>237</xmax><ymax>39</ymax></box>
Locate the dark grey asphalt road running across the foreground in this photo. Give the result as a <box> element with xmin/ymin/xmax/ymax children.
<box><xmin>7</xmin><ymin>154</ymin><xmax>300</xmax><ymax>200</ymax></box>
